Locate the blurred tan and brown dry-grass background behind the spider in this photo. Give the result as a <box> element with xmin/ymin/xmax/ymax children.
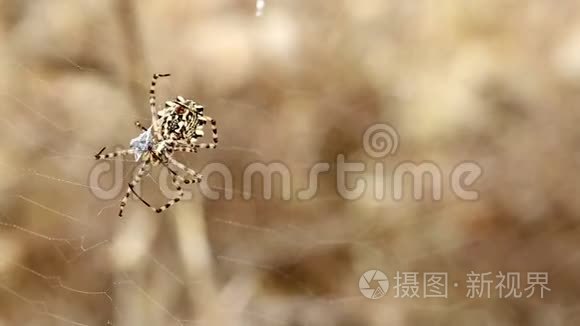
<box><xmin>0</xmin><ymin>0</ymin><xmax>580</xmax><ymax>326</ymax></box>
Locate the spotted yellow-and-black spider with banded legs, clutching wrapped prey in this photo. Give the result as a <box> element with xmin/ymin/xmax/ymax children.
<box><xmin>95</xmin><ymin>74</ymin><xmax>218</xmax><ymax>217</ymax></box>
